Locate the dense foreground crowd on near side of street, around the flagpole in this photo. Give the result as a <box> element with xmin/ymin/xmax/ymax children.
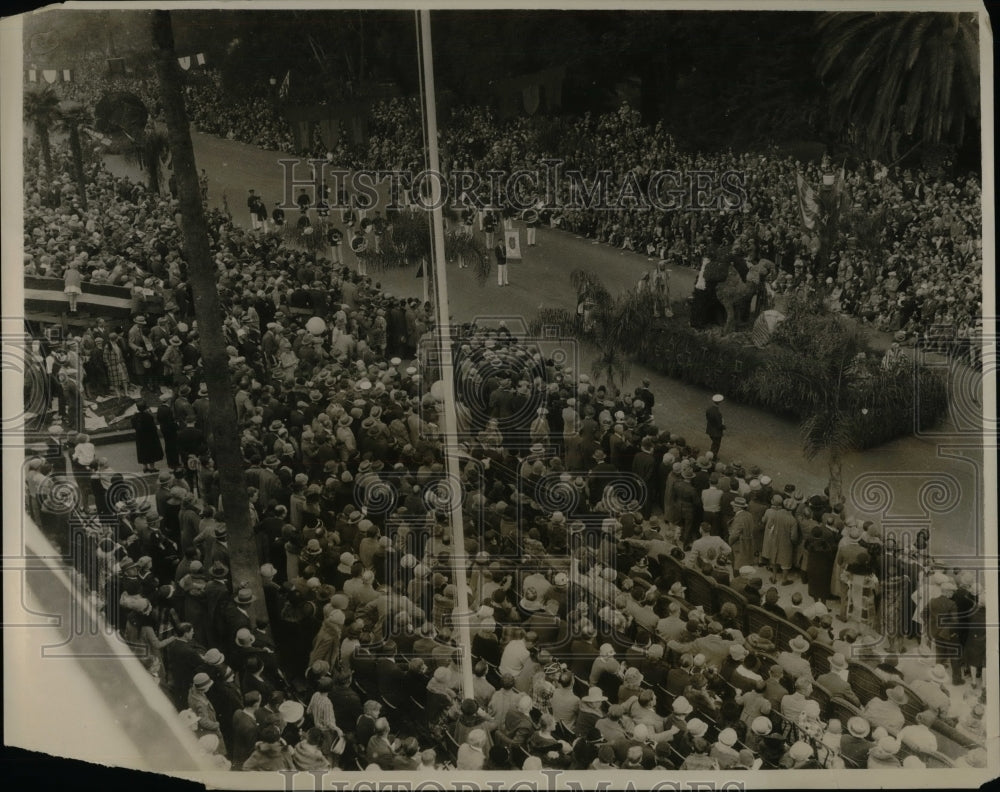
<box><xmin>25</xmin><ymin>120</ymin><xmax>986</xmax><ymax>770</ymax></box>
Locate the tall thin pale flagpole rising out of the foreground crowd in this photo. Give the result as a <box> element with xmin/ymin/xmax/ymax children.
<box><xmin>417</xmin><ymin>9</ymin><xmax>475</xmax><ymax>698</ymax></box>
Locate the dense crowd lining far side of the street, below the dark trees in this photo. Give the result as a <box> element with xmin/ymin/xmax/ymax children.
<box><xmin>43</xmin><ymin>70</ymin><xmax>982</xmax><ymax>347</ymax></box>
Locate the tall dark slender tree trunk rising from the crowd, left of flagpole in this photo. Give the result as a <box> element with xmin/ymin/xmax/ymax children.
<box><xmin>151</xmin><ymin>11</ymin><xmax>264</xmax><ymax>617</ymax></box>
